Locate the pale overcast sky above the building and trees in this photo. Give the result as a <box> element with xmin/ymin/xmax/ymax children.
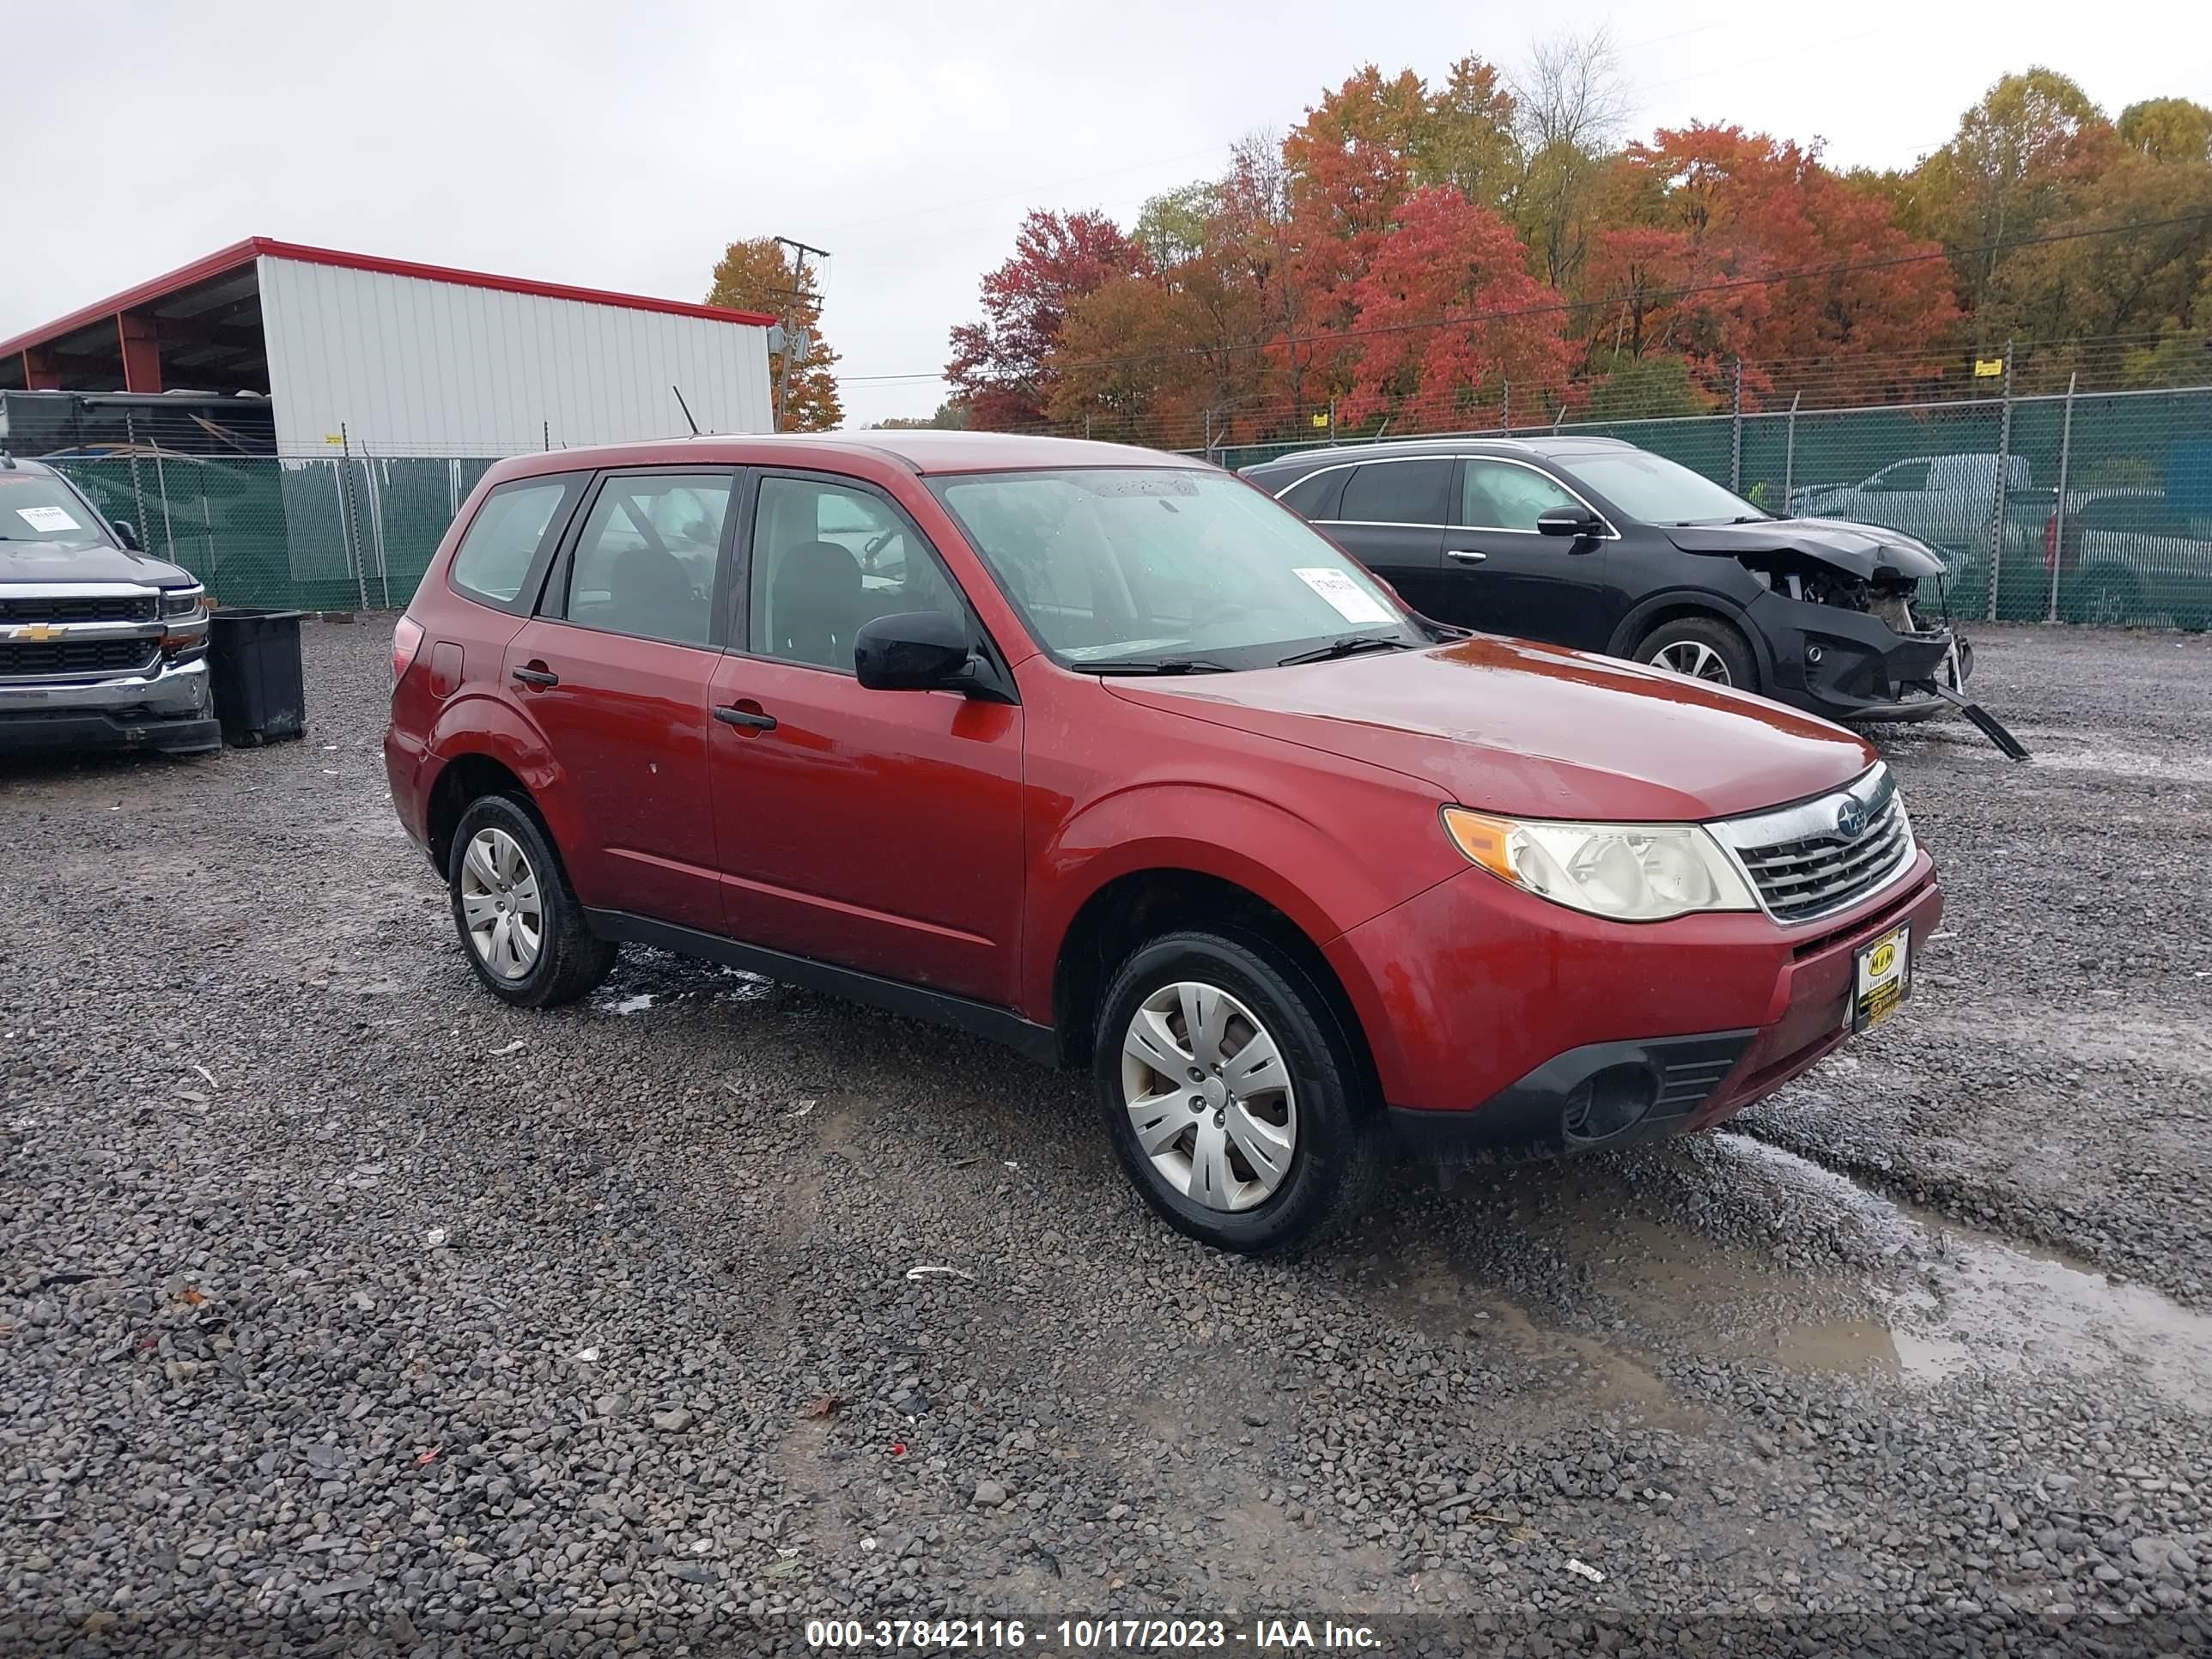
<box><xmin>0</xmin><ymin>0</ymin><xmax>2212</xmax><ymax>425</ymax></box>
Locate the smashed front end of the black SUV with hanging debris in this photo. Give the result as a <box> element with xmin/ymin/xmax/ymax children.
<box><xmin>1666</xmin><ymin>518</ymin><xmax>2027</xmax><ymax>759</ymax></box>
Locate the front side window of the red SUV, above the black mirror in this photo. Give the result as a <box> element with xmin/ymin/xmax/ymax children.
<box><xmin>745</xmin><ymin>477</ymin><xmax>967</xmax><ymax>675</ymax></box>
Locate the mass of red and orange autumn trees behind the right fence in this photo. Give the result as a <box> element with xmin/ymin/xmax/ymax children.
<box><xmin>947</xmin><ymin>47</ymin><xmax>2212</xmax><ymax>447</ymax></box>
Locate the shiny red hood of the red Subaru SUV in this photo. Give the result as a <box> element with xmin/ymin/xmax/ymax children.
<box><xmin>1106</xmin><ymin>635</ymin><xmax>1874</xmax><ymax>823</ymax></box>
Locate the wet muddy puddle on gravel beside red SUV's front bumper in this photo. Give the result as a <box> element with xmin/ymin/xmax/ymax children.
<box><xmin>1363</xmin><ymin>1133</ymin><xmax>2212</xmax><ymax>1431</ymax></box>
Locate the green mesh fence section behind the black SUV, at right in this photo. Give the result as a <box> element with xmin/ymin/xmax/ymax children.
<box><xmin>1210</xmin><ymin>387</ymin><xmax>2212</xmax><ymax>629</ymax></box>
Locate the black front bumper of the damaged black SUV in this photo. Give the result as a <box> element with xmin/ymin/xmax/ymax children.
<box><xmin>1750</xmin><ymin>592</ymin><xmax>1973</xmax><ymax>721</ymax></box>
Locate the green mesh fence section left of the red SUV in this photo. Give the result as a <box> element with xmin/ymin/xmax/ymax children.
<box><xmin>53</xmin><ymin>452</ymin><xmax>491</xmax><ymax>611</ymax></box>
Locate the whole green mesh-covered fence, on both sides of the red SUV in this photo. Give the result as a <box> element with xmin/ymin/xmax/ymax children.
<box><xmin>43</xmin><ymin>387</ymin><xmax>2212</xmax><ymax>629</ymax></box>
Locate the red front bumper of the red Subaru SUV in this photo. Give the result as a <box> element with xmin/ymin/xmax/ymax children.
<box><xmin>1328</xmin><ymin>852</ymin><xmax>1942</xmax><ymax>1157</ymax></box>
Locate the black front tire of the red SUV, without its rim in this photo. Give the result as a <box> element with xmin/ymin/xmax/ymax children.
<box><xmin>1093</xmin><ymin>933</ymin><xmax>1382</xmax><ymax>1256</ymax></box>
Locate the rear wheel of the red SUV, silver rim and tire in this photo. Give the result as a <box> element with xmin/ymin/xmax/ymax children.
<box><xmin>447</xmin><ymin>794</ymin><xmax>619</xmax><ymax>1009</ymax></box>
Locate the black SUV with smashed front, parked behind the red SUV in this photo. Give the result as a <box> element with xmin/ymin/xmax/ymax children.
<box><xmin>1243</xmin><ymin>438</ymin><xmax>1973</xmax><ymax>721</ymax></box>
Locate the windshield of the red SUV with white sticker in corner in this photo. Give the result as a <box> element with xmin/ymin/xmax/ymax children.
<box><xmin>936</xmin><ymin>467</ymin><xmax>1431</xmax><ymax>672</ymax></box>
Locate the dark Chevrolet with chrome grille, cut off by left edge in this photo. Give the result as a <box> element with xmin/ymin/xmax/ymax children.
<box><xmin>0</xmin><ymin>453</ymin><xmax>223</xmax><ymax>754</ymax></box>
